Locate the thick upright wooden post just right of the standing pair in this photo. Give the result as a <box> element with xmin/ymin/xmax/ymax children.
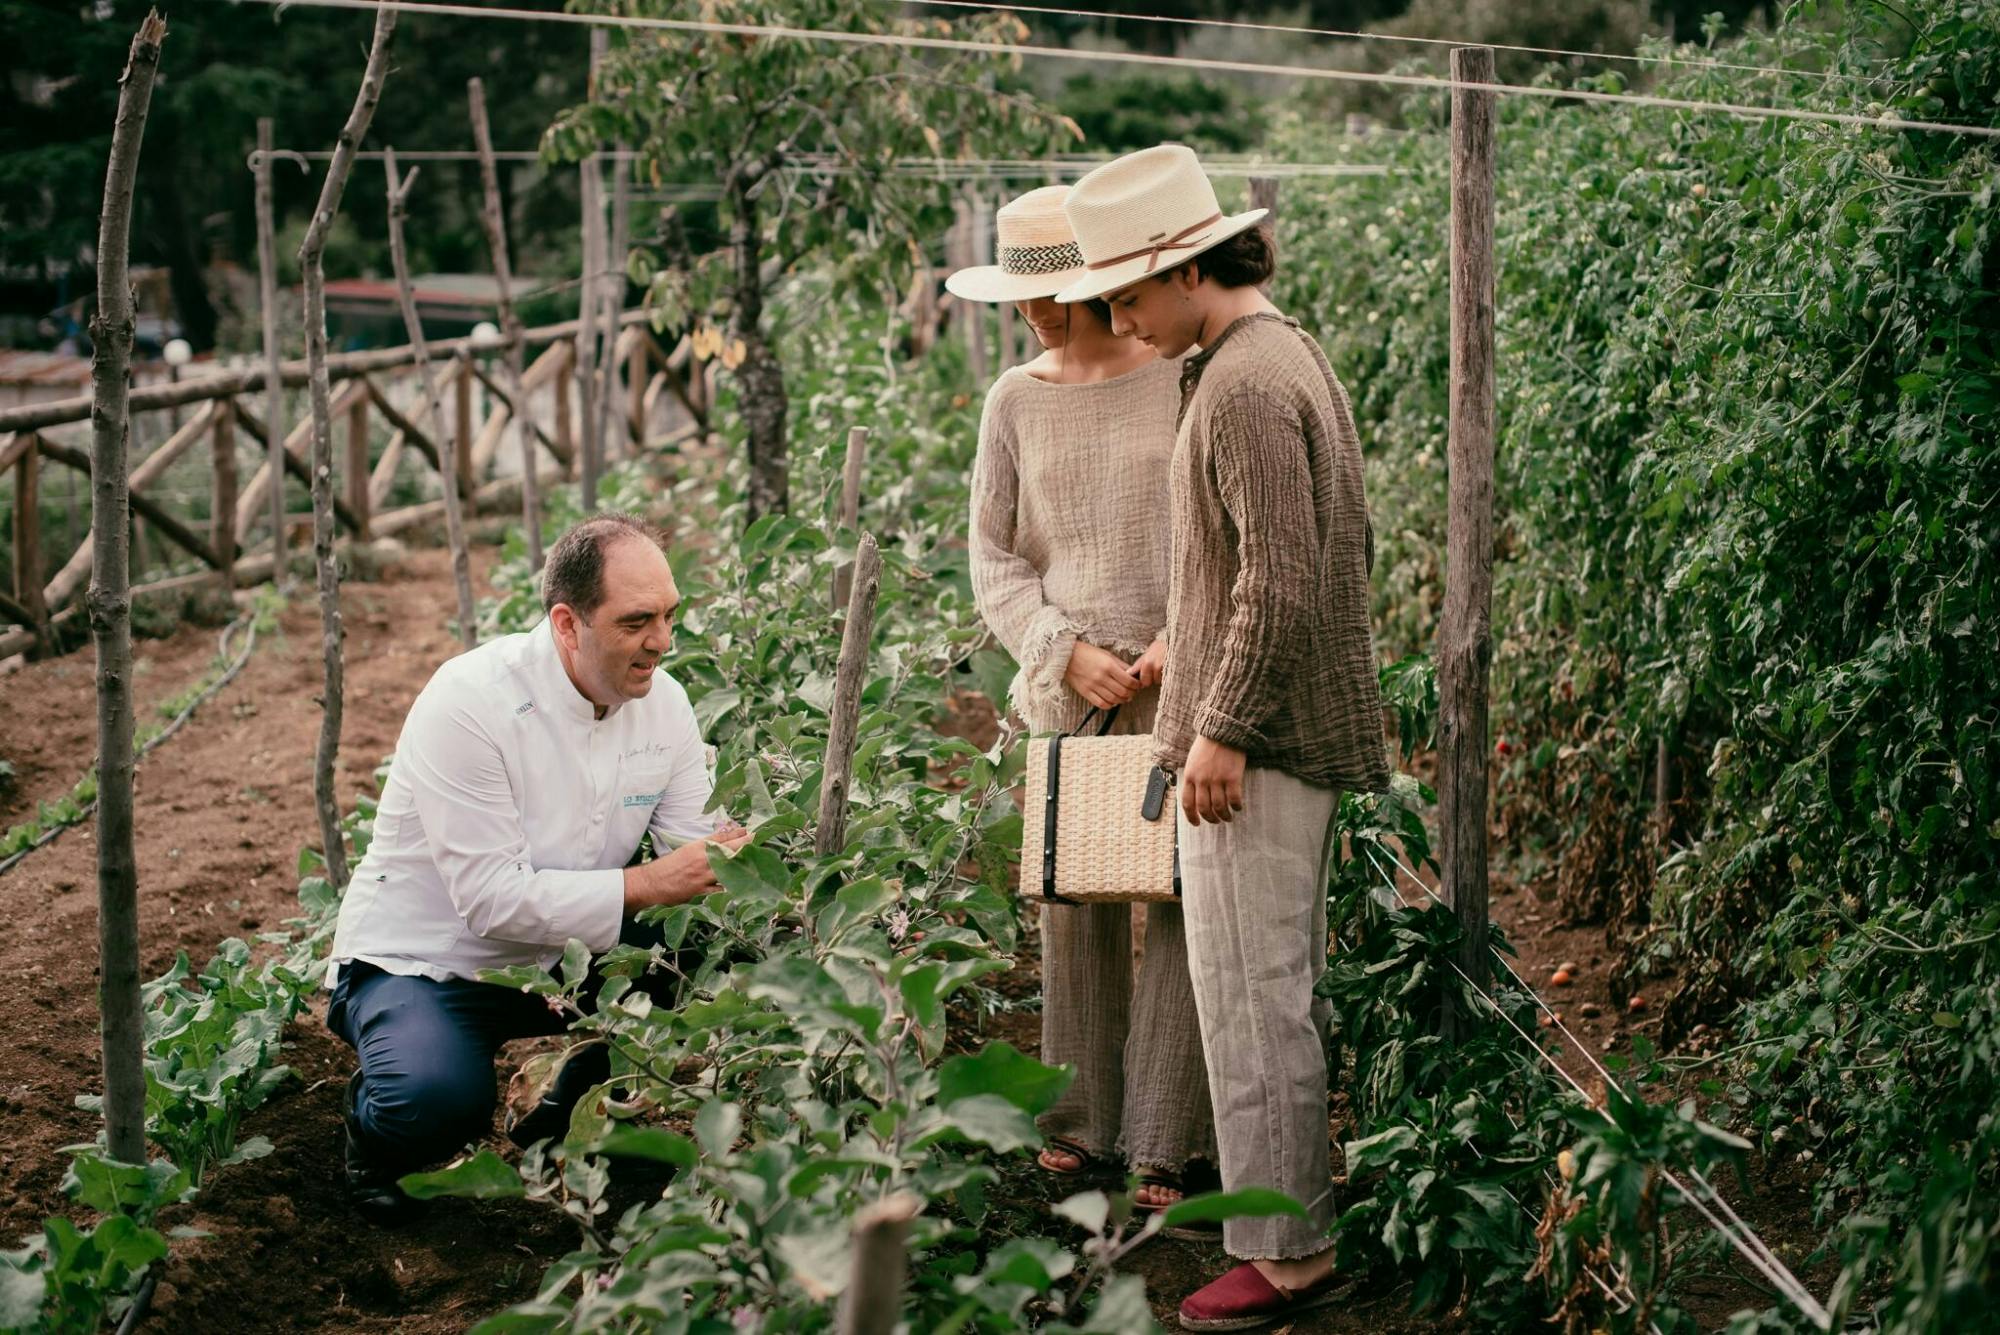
<box><xmin>1438</xmin><ymin>46</ymin><xmax>1494</xmax><ymax>1015</ymax></box>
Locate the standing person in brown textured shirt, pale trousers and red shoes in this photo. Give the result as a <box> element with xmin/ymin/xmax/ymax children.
<box><xmin>1056</xmin><ymin>144</ymin><xmax>1388</xmax><ymax>1331</ymax></box>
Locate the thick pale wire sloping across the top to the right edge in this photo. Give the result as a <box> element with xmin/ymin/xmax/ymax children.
<box><xmin>227</xmin><ymin>0</ymin><xmax>2000</xmax><ymax>140</ymax></box>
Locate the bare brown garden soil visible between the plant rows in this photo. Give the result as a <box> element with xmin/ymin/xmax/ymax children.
<box><xmin>0</xmin><ymin>552</ymin><xmax>1814</xmax><ymax>1335</ymax></box>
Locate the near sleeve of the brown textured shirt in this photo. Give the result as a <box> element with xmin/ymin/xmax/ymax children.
<box><xmin>1194</xmin><ymin>386</ymin><xmax>1318</xmax><ymax>751</ymax></box>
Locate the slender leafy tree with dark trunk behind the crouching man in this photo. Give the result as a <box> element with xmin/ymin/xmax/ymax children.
<box><xmin>548</xmin><ymin>0</ymin><xmax>1082</xmax><ymax>518</ymax></box>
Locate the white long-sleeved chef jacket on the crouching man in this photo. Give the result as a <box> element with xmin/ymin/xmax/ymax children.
<box><xmin>328</xmin><ymin>622</ymin><xmax>718</xmax><ymax>985</ymax></box>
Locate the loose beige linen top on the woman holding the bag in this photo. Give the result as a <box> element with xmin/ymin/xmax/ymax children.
<box><xmin>970</xmin><ymin>360</ymin><xmax>1180</xmax><ymax>731</ymax></box>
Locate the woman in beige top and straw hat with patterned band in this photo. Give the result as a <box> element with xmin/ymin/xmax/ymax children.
<box><xmin>944</xmin><ymin>186</ymin><xmax>1216</xmax><ymax>1209</ymax></box>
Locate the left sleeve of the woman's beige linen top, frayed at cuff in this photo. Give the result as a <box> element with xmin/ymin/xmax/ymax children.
<box><xmin>970</xmin><ymin>386</ymin><xmax>1080</xmax><ymax>705</ymax></box>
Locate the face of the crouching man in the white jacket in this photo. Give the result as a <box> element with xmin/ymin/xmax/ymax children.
<box><xmin>550</xmin><ymin>538</ymin><xmax>680</xmax><ymax>707</ymax></box>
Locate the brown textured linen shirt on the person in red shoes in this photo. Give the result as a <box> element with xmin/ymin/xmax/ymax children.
<box><xmin>1154</xmin><ymin>314</ymin><xmax>1388</xmax><ymax>791</ymax></box>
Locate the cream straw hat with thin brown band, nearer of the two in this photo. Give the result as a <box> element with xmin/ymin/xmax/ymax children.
<box><xmin>1056</xmin><ymin>144</ymin><xmax>1270</xmax><ymax>302</ymax></box>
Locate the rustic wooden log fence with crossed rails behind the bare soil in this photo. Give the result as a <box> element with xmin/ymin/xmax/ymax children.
<box><xmin>0</xmin><ymin>301</ymin><xmax>710</xmax><ymax>658</ymax></box>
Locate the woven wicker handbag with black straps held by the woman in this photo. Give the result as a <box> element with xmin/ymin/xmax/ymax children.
<box><xmin>1020</xmin><ymin>709</ymin><xmax>1180</xmax><ymax>903</ymax></box>
